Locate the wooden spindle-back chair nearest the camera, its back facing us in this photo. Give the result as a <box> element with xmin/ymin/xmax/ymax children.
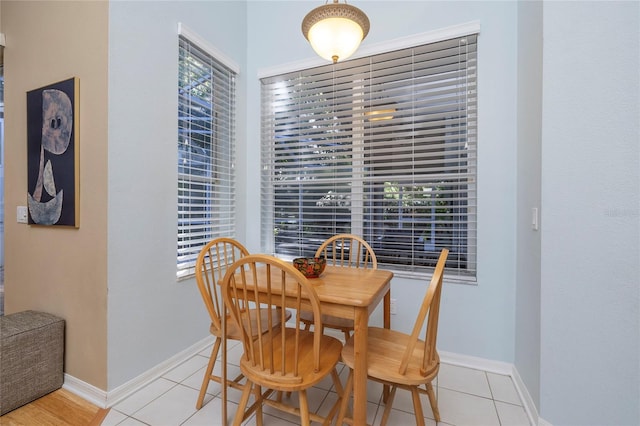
<box><xmin>222</xmin><ymin>255</ymin><xmax>343</xmax><ymax>425</ymax></box>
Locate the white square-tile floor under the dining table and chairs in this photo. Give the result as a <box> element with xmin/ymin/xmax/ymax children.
<box><xmin>102</xmin><ymin>342</ymin><xmax>529</xmax><ymax>426</ymax></box>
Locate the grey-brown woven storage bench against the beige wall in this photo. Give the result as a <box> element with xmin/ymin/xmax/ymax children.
<box><xmin>0</xmin><ymin>311</ymin><xmax>64</xmax><ymax>415</ymax></box>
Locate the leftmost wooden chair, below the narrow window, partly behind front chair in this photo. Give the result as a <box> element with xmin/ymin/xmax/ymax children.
<box><xmin>195</xmin><ymin>238</ymin><xmax>291</xmax><ymax>410</ymax></box>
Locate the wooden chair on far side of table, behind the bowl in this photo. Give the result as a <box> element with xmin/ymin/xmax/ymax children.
<box><xmin>302</xmin><ymin>234</ymin><xmax>378</xmax><ymax>340</ymax></box>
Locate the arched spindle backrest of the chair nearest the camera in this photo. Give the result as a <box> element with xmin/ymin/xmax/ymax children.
<box><xmin>222</xmin><ymin>254</ymin><xmax>322</xmax><ymax>383</ymax></box>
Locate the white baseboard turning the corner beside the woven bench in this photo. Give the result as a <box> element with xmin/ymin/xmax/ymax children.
<box><xmin>62</xmin><ymin>337</ymin><xmax>212</xmax><ymax>408</ymax></box>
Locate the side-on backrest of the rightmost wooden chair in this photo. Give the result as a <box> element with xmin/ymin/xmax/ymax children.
<box><xmin>400</xmin><ymin>249</ymin><xmax>449</xmax><ymax>376</ymax></box>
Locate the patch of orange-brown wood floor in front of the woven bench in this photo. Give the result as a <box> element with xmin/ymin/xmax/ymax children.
<box><xmin>0</xmin><ymin>389</ymin><xmax>109</xmax><ymax>426</ymax></box>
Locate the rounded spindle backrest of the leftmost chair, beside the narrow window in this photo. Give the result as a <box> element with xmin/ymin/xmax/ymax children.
<box><xmin>195</xmin><ymin>237</ymin><xmax>249</xmax><ymax>333</ymax></box>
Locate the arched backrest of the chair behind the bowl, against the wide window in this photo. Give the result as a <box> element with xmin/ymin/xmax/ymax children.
<box><xmin>316</xmin><ymin>234</ymin><xmax>378</xmax><ymax>269</ymax></box>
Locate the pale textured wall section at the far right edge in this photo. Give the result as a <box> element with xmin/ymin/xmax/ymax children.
<box><xmin>540</xmin><ymin>1</ymin><xmax>640</xmax><ymax>425</ymax></box>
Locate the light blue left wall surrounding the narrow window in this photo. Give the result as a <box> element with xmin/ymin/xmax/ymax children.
<box><xmin>108</xmin><ymin>1</ymin><xmax>247</xmax><ymax>390</ymax></box>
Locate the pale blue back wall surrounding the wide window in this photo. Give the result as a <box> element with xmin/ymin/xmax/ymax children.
<box><xmin>243</xmin><ymin>1</ymin><xmax>517</xmax><ymax>362</ymax></box>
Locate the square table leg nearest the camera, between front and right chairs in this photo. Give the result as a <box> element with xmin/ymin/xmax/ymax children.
<box><xmin>353</xmin><ymin>307</ymin><xmax>369</xmax><ymax>425</ymax></box>
